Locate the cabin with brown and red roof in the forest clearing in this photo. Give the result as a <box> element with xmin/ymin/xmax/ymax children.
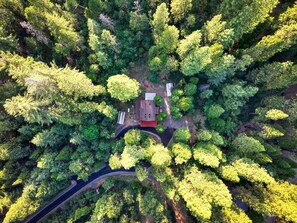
<box><xmin>136</xmin><ymin>93</ymin><xmax>160</xmax><ymax>127</ymax></box>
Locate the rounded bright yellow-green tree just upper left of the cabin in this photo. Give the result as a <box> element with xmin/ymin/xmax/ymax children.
<box><xmin>107</xmin><ymin>74</ymin><xmax>140</xmax><ymax>102</ymax></box>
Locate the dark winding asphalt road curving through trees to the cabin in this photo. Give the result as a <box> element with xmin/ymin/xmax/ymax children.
<box><xmin>25</xmin><ymin>126</ymin><xmax>174</xmax><ymax>223</ymax></box>
